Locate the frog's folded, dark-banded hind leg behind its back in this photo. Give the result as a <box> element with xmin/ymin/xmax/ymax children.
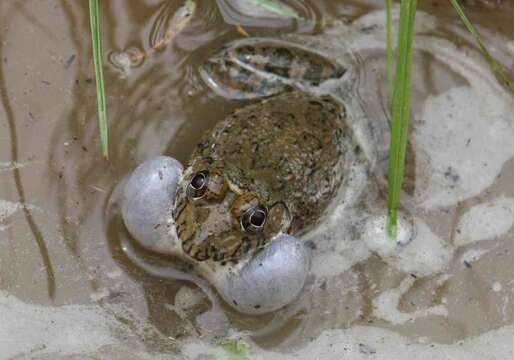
<box><xmin>200</xmin><ymin>38</ymin><xmax>346</xmax><ymax>99</ymax></box>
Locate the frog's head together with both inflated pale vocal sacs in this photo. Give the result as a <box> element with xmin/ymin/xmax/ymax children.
<box><xmin>121</xmin><ymin>156</ymin><xmax>310</xmax><ymax>314</ymax></box>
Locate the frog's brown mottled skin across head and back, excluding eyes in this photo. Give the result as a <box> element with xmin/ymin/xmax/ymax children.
<box><xmin>174</xmin><ymin>91</ymin><xmax>359</xmax><ymax>264</ymax></box>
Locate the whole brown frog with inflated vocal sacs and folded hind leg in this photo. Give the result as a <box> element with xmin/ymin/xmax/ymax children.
<box><xmin>122</xmin><ymin>33</ymin><xmax>408</xmax><ymax>314</ymax></box>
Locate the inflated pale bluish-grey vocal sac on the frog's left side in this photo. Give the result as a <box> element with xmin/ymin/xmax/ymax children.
<box><xmin>121</xmin><ymin>156</ymin><xmax>183</xmax><ymax>253</ymax></box>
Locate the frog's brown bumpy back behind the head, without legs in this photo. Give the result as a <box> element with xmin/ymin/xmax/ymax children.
<box><xmin>193</xmin><ymin>92</ymin><xmax>358</xmax><ymax>233</ymax></box>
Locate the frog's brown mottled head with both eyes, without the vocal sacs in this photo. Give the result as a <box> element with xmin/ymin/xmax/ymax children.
<box><xmin>174</xmin><ymin>158</ymin><xmax>291</xmax><ymax>263</ymax></box>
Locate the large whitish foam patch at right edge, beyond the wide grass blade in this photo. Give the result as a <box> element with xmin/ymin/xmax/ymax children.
<box><xmin>413</xmin><ymin>86</ymin><xmax>514</xmax><ymax>208</ymax></box>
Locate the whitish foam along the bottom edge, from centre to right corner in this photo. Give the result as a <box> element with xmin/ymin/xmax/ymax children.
<box><xmin>184</xmin><ymin>326</ymin><xmax>514</xmax><ymax>360</ymax></box>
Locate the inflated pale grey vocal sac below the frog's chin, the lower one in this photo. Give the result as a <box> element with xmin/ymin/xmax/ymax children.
<box><xmin>208</xmin><ymin>234</ymin><xmax>310</xmax><ymax>314</ymax></box>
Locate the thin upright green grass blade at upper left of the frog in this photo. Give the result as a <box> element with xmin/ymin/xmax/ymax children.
<box><xmin>89</xmin><ymin>0</ymin><xmax>109</xmax><ymax>158</ymax></box>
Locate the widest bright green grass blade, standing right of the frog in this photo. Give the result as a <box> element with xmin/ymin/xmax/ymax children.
<box><xmin>387</xmin><ymin>0</ymin><xmax>417</xmax><ymax>239</ymax></box>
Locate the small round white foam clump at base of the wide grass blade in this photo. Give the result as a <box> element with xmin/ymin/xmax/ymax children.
<box><xmin>362</xmin><ymin>211</ymin><xmax>416</xmax><ymax>257</ymax></box>
